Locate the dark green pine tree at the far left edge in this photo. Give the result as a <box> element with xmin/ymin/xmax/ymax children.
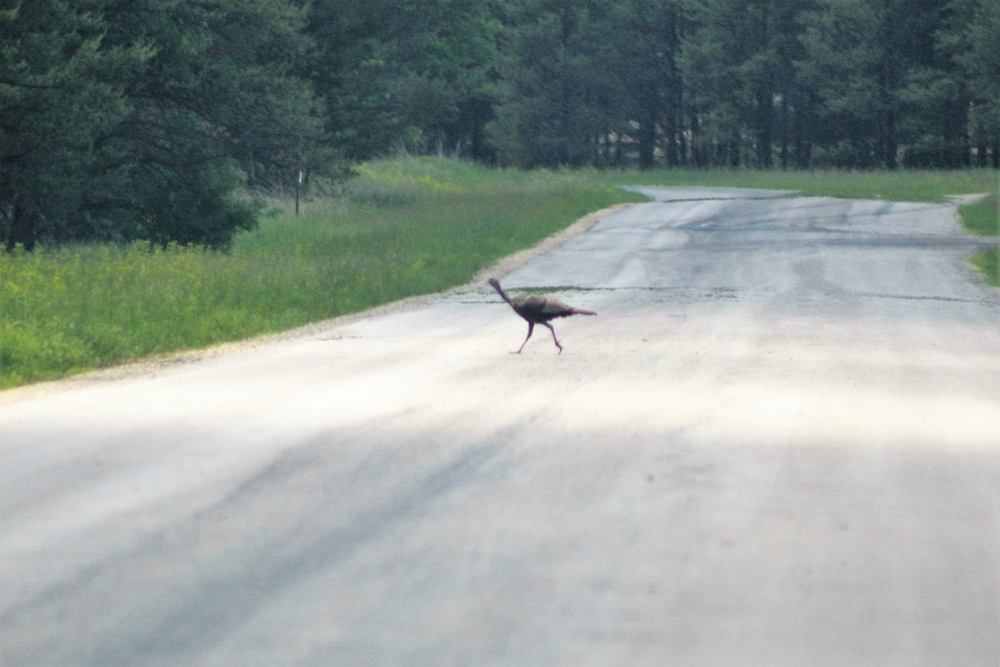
<box><xmin>0</xmin><ymin>0</ymin><xmax>150</xmax><ymax>250</ymax></box>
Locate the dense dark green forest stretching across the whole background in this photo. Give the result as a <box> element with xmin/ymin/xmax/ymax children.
<box><xmin>0</xmin><ymin>0</ymin><xmax>1000</xmax><ymax>250</ymax></box>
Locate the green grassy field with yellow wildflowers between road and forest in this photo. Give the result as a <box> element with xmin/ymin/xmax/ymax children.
<box><xmin>0</xmin><ymin>158</ymin><xmax>996</xmax><ymax>388</ymax></box>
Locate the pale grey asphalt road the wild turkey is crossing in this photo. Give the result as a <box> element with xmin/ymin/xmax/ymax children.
<box><xmin>0</xmin><ymin>188</ymin><xmax>1000</xmax><ymax>667</ymax></box>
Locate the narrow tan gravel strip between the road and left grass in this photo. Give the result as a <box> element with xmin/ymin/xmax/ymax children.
<box><xmin>0</xmin><ymin>204</ymin><xmax>635</xmax><ymax>405</ymax></box>
